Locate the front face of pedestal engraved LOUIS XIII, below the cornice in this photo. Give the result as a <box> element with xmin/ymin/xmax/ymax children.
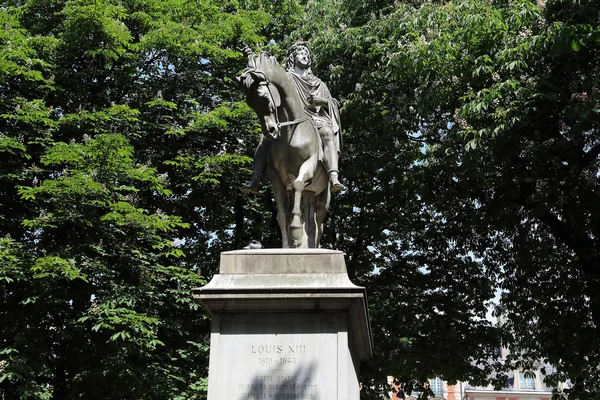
<box><xmin>209</xmin><ymin>313</ymin><xmax>348</xmax><ymax>400</ymax></box>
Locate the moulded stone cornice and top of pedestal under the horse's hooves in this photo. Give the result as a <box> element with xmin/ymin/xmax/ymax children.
<box><xmin>193</xmin><ymin>249</ymin><xmax>373</xmax><ymax>358</ymax></box>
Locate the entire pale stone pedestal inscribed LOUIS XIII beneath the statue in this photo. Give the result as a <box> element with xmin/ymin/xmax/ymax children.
<box><xmin>194</xmin><ymin>249</ymin><xmax>372</xmax><ymax>400</ymax></box>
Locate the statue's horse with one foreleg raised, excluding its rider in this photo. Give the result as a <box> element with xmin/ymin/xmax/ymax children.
<box><xmin>238</xmin><ymin>53</ymin><xmax>331</xmax><ymax>248</ymax></box>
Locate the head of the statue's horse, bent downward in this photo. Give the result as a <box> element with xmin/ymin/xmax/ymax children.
<box><xmin>238</xmin><ymin>68</ymin><xmax>281</xmax><ymax>140</ymax></box>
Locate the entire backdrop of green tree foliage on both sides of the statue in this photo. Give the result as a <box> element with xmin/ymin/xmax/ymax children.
<box><xmin>0</xmin><ymin>0</ymin><xmax>600</xmax><ymax>399</ymax></box>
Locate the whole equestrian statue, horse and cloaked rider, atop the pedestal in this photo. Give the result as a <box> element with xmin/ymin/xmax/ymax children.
<box><xmin>238</xmin><ymin>42</ymin><xmax>344</xmax><ymax>248</ymax></box>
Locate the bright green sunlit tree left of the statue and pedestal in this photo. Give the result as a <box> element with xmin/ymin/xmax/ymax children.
<box><xmin>0</xmin><ymin>0</ymin><xmax>301</xmax><ymax>399</ymax></box>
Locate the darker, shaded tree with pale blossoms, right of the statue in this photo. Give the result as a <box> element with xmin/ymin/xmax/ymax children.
<box><xmin>290</xmin><ymin>0</ymin><xmax>600</xmax><ymax>398</ymax></box>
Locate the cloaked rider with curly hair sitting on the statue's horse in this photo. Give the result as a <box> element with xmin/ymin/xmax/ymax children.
<box><xmin>242</xmin><ymin>42</ymin><xmax>344</xmax><ymax>194</ymax></box>
